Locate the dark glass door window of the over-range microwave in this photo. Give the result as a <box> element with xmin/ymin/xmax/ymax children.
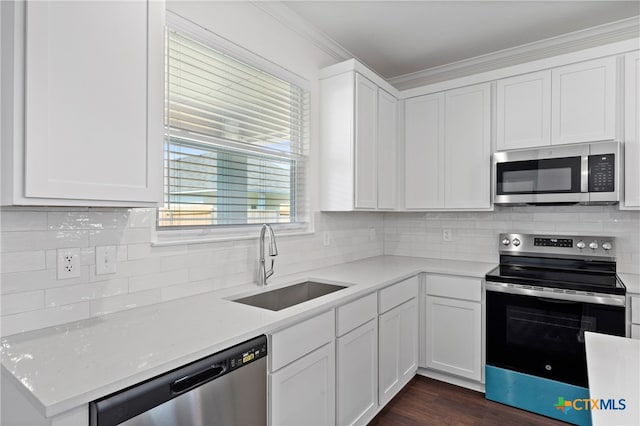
<box><xmin>497</xmin><ymin>157</ymin><xmax>581</xmax><ymax>195</ymax></box>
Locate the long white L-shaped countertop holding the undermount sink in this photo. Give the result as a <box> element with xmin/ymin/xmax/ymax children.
<box><xmin>1</xmin><ymin>256</ymin><xmax>495</xmax><ymax>417</ymax></box>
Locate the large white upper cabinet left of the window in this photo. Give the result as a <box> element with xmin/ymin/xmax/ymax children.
<box><xmin>2</xmin><ymin>1</ymin><xmax>164</xmax><ymax>206</ymax></box>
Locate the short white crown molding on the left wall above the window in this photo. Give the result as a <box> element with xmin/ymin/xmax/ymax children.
<box><xmin>251</xmin><ymin>1</ymin><xmax>357</xmax><ymax>62</ymax></box>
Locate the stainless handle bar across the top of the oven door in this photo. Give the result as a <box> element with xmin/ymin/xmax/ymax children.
<box><xmin>485</xmin><ymin>281</ymin><xmax>625</xmax><ymax>308</ymax></box>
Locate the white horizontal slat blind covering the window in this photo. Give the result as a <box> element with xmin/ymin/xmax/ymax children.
<box><xmin>158</xmin><ymin>29</ymin><xmax>309</xmax><ymax>229</ymax></box>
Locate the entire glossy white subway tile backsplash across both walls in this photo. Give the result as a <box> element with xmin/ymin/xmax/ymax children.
<box><xmin>0</xmin><ymin>206</ymin><xmax>640</xmax><ymax>335</ymax></box>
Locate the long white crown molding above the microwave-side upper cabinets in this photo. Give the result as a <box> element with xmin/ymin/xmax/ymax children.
<box><xmin>387</xmin><ymin>16</ymin><xmax>640</xmax><ymax>90</ymax></box>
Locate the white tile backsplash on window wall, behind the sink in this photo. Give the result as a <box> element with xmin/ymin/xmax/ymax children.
<box><xmin>0</xmin><ymin>208</ymin><xmax>383</xmax><ymax>336</ymax></box>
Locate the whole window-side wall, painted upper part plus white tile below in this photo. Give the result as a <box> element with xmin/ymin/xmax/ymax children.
<box><xmin>0</xmin><ymin>0</ymin><xmax>383</xmax><ymax>335</ymax></box>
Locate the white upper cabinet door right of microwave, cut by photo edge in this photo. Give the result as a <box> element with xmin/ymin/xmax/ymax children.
<box><xmin>624</xmin><ymin>51</ymin><xmax>640</xmax><ymax>207</ymax></box>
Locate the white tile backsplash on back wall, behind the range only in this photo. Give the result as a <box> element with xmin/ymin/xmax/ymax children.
<box><xmin>384</xmin><ymin>206</ymin><xmax>640</xmax><ymax>274</ymax></box>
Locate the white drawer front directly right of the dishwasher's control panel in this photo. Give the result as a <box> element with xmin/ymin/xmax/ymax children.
<box><xmin>269</xmin><ymin>310</ymin><xmax>335</xmax><ymax>371</ymax></box>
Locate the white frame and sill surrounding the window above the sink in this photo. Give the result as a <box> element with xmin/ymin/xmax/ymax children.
<box><xmin>156</xmin><ymin>11</ymin><xmax>314</xmax><ymax>246</ymax></box>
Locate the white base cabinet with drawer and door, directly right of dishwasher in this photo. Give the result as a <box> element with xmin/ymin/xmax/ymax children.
<box><xmin>268</xmin><ymin>310</ymin><xmax>335</xmax><ymax>426</ymax></box>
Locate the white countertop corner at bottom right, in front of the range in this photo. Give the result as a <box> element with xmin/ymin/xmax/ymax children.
<box><xmin>585</xmin><ymin>332</ymin><xmax>640</xmax><ymax>426</ymax></box>
